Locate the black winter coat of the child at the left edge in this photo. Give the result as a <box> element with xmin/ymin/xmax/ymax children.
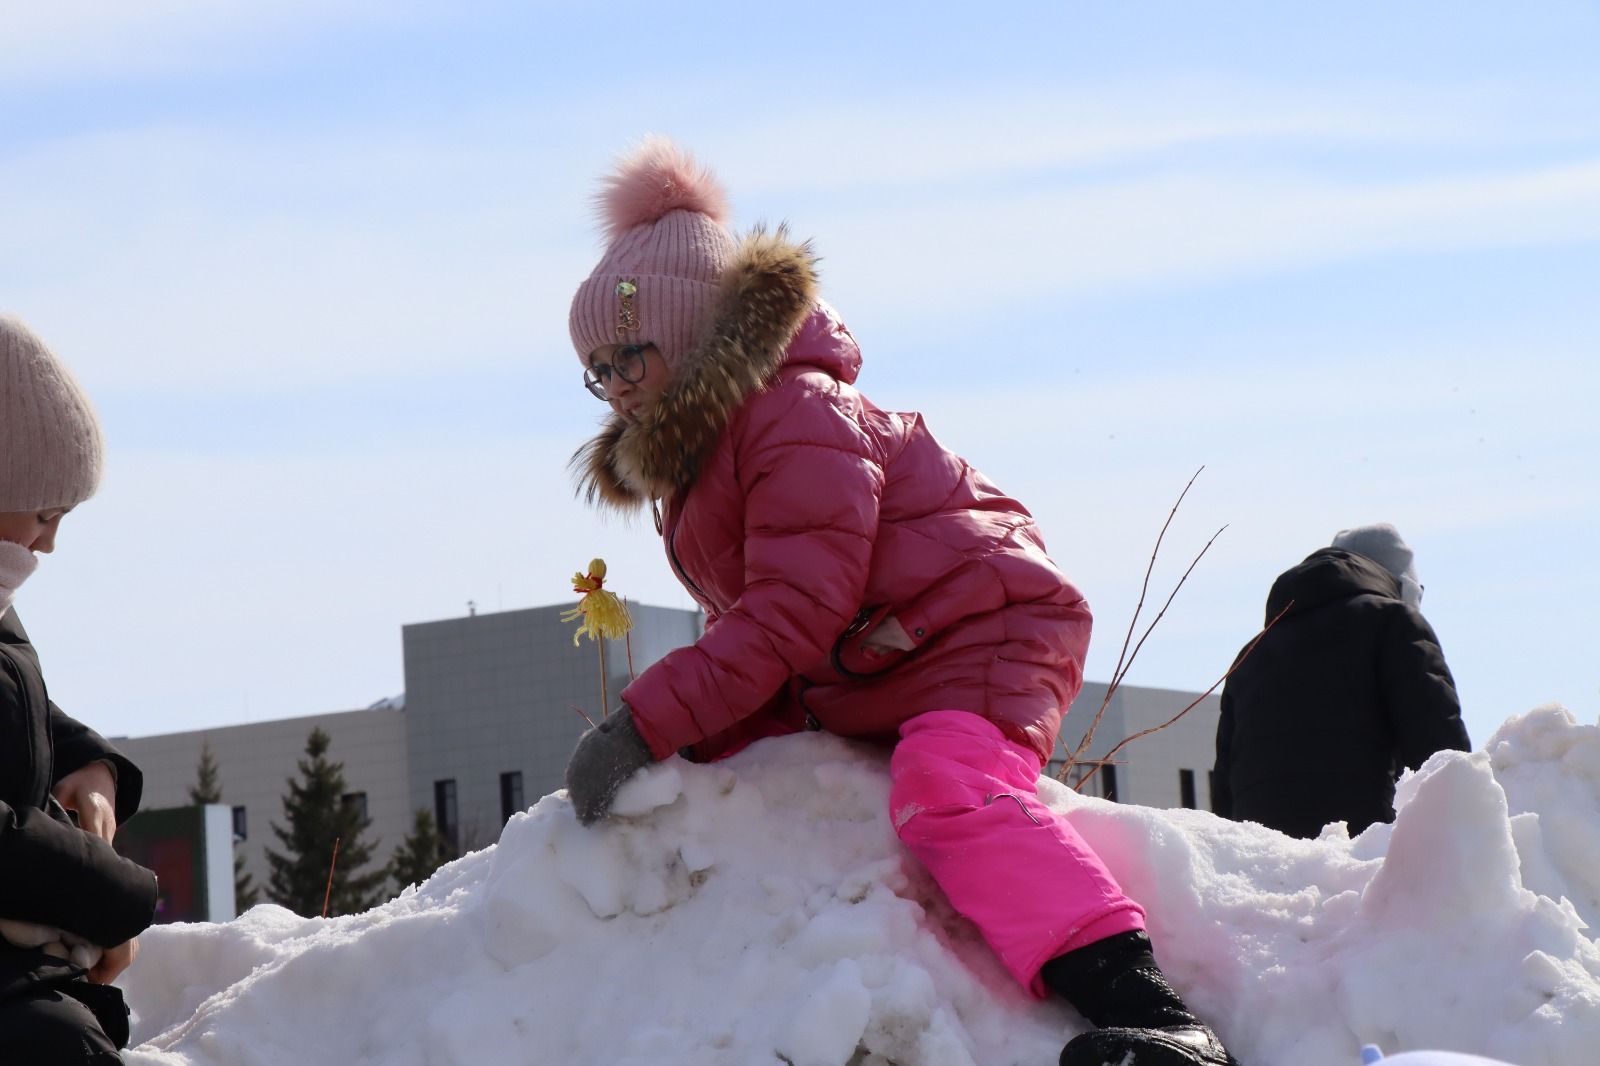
<box><xmin>0</xmin><ymin>610</ymin><xmax>155</xmax><ymax>973</ymax></box>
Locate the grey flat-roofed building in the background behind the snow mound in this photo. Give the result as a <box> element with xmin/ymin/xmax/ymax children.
<box><xmin>115</xmin><ymin>605</ymin><xmax>1218</xmax><ymax>888</ymax></box>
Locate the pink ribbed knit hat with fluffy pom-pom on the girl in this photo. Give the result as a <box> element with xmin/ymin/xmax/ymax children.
<box><xmin>568</xmin><ymin>136</ymin><xmax>734</xmax><ymax>367</ymax></box>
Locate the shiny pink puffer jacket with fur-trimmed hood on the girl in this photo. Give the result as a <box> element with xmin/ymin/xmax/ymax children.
<box><xmin>581</xmin><ymin>234</ymin><xmax>1090</xmax><ymax>760</ymax></box>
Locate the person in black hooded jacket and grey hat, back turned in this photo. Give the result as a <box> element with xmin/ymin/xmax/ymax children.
<box><xmin>1213</xmin><ymin>523</ymin><xmax>1470</xmax><ymax>839</ymax></box>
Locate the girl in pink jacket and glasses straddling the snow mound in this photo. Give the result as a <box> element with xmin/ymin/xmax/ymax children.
<box><xmin>566</xmin><ymin>139</ymin><xmax>1234</xmax><ymax>1066</ymax></box>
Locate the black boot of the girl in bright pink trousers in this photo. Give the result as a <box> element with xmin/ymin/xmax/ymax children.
<box><xmin>1042</xmin><ymin>930</ymin><xmax>1238</xmax><ymax>1066</ymax></box>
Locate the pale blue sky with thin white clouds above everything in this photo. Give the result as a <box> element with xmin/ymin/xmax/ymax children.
<box><xmin>0</xmin><ymin>0</ymin><xmax>1600</xmax><ymax>743</ymax></box>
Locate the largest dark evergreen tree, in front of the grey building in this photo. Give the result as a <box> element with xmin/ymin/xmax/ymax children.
<box><xmin>267</xmin><ymin>728</ymin><xmax>389</xmax><ymax>917</ymax></box>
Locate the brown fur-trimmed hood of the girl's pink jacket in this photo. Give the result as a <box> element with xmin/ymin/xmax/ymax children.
<box><xmin>573</xmin><ymin>229</ymin><xmax>832</xmax><ymax>511</ymax></box>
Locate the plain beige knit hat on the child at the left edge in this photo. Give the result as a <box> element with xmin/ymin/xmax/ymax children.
<box><xmin>0</xmin><ymin>315</ymin><xmax>106</xmax><ymax>512</ymax></box>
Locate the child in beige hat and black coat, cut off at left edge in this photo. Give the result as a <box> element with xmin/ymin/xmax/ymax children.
<box><xmin>0</xmin><ymin>317</ymin><xmax>155</xmax><ymax>1066</ymax></box>
